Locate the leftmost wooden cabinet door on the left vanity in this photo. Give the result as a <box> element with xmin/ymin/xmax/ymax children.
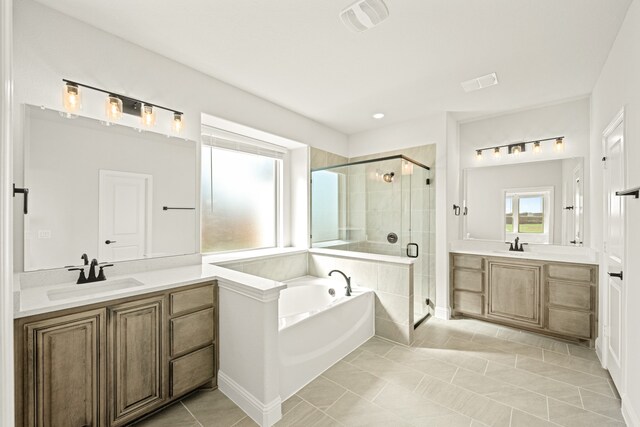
<box><xmin>23</xmin><ymin>309</ymin><xmax>107</xmax><ymax>427</ymax></box>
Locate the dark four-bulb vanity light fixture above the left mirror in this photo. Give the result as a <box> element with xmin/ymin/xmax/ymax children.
<box><xmin>62</xmin><ymin>79</ymin><xmax>184</xmax><ymax>133</ymax></box>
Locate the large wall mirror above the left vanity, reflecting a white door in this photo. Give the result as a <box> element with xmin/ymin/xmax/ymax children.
<box><xmin>21</xmin><ymin>106</ymin><xmax>200</xmax><ymax>271</ymax></box>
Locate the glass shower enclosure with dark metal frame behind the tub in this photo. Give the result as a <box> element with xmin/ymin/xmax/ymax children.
<box><xmin>311</xmin><ymin>155</ymin><xmax>435</xmax><ymax>324</ymax></box>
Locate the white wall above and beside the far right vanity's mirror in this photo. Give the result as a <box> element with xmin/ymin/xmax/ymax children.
<box><xmin>460</xmin><ymin>98</ymin><xmax>591</xmax><ymax>245</ymax></box>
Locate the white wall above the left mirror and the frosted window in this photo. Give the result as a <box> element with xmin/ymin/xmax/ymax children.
<box><xmin>14</xmin><ymin>0</ymin><xmax>347</xmax><ymax>269</ymax></box>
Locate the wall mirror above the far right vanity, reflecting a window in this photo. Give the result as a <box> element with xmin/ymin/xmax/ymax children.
<box><xmin>463</xmin><ymin>157</ymin><xmax>585</xmax><ymax>246</ymax></box>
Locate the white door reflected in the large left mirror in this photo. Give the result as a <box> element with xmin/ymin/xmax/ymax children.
<box><xmin>98</xmin><ymin>170</ymin><xmax>152</xmax><ymax>262</ymax></box>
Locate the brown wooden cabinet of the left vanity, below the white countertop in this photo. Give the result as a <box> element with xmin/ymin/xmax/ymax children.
<box><xmin>15</xmin><ymin>281</ymin><xmax>218</xmax><ymax>426</ymax></box>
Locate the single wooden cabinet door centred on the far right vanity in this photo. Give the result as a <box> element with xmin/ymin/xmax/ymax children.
<box><xmin>487</xmin><ymin>262</ymin><xmax>542</xmax><ymax>326</ymax></box>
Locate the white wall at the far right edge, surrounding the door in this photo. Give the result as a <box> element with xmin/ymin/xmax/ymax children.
<box><xmin>591</xmin><ymin>0</ymin><xmax>640</xmax><ymax>427</ymax></box>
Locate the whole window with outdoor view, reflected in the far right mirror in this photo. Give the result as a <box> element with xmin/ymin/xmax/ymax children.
<box><xmin>504</xmin><ymin>188</ymin><xmax>553</xmax><ymax>243</ymax></box>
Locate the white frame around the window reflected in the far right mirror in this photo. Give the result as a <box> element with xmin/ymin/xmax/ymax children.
<box><xmin>502</xmin><ymin>187</ymin><xmax>554</xmax><ymax>245</ymax></box>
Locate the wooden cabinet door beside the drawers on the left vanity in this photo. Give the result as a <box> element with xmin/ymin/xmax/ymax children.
<box><xmin>109</xmin><ymin>296</ymin><xmax>165</xmax><ymax>426</ymax></box>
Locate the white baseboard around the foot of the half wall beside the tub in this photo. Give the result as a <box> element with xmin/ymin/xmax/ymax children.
<box><xmin>218</xmin><ymin>371</ymin><xmax>282</xmax><ymax>427</ymax></box>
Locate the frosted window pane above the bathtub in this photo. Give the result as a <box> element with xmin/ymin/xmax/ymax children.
<box><xmin>201</xmin><ymin>147</ymin><xmax>280</xmax><ymax>253</ymax></box>
